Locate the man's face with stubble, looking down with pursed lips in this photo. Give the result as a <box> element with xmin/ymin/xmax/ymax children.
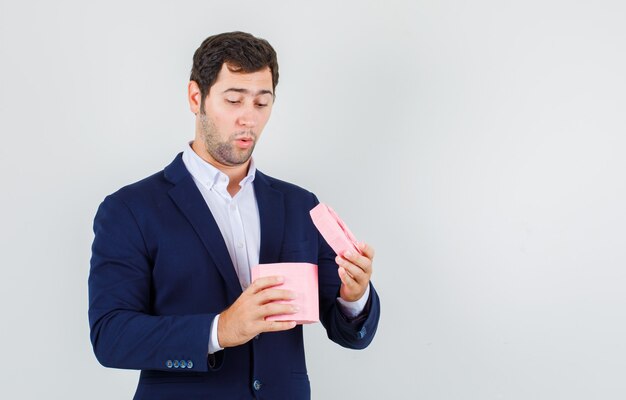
<box><xmin>189</xmin><ymin>64</ymin><xmax>274</xmax><ymax>167</ymax></box>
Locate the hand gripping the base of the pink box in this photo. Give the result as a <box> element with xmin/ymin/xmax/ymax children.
<box><xmin>217</xmin><ymin>276</ymin><xmax>298</xmax><ymax>348</ymax></box>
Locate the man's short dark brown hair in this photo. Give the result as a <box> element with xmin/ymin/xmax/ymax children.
<box><xmin>189</xmin><ymin>32</ymin><xmax>278</xmax><ymax>103</ymax></box>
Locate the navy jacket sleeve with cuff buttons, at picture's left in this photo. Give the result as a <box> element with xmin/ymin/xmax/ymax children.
<box><xmin>88</xmin><ymin>195</ymin><xmax>215</xmax><ymax>372</ymax></box>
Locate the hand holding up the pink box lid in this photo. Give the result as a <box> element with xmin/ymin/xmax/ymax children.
<box><xmin>335</xmin><ymin>242</ymin><xmax>374</xmax><ymax>301</ymax></box>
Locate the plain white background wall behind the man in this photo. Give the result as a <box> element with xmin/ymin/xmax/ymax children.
<box><xmin>0</xmin><ymin>0</ymin><xmax>626</xmax><ymax>400</ymax></box>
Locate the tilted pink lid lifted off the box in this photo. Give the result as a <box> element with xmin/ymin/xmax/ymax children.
<box><xmin>310</xmin><ymin>203</ymin><xmax>362</xmax><ymax>256</ymax></box>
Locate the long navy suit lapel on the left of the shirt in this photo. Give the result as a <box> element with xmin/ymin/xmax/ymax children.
<box><xmin>164</xmin><ymin>154</ymin><xmax>241</xmax><ymax>301</ymax></box>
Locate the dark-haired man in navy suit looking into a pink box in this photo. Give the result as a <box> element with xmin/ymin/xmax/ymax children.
<box><xmin>89</xmin><ymin>32</ymin><xmax>380</xmax><ymax>400</ymax></box>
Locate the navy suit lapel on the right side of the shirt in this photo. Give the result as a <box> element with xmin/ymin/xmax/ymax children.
<box><xmin>254</xmin><ymin>170</ymin><xmax>285</xmax><ymax>264</ymax></box>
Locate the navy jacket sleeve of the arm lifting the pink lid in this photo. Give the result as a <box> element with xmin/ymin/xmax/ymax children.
<box><xmin>314</xmin><ymin>198</ymin><xmax>380</xmax><ymax>349</ymax></box>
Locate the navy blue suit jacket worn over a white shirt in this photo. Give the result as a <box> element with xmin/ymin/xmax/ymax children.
<box><xmin>89</xmin><ymin>154</ymin><xmax>380</xmax><ymax>400</ymax></box>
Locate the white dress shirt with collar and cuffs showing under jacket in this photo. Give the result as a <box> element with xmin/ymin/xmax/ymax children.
<box><xmin>183</xmin><ymin>143</ymin><xmax>369</xmax><ymax>354</ymax></box>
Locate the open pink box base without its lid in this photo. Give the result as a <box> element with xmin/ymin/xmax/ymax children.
<box><xmin>251</xmin><ymin>263</ymin><xmax>320</xmax><ymax>324</ymax></box>
